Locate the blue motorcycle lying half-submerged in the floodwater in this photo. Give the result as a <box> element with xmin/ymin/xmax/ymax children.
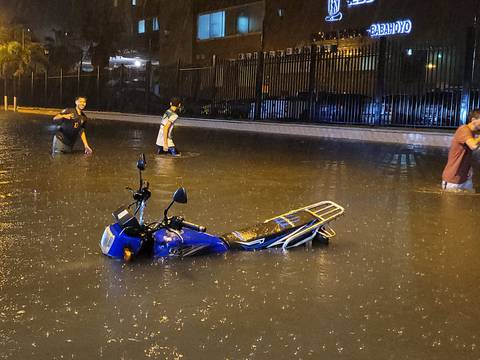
<box><xmin>100</xmin><ymin>154</ymin><xmax>345</xmax><ymax>261</ymax></box>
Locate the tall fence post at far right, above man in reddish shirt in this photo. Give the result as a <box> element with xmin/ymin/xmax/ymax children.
<box><xmin>460</xmin><ymin>26</ymin><xmax>476</xmax><ymax>124</ymax></box>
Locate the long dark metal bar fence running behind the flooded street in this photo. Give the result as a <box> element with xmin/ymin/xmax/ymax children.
<box><xmin>3</xmin><ymin>33</ymin><xmax>480</xmax><ymax>128</ymax></box>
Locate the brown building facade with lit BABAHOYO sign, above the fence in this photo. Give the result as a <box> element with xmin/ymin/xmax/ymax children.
<box><xmin>122</xmin><ymin>0</ymin><xmax>478</xmax><ymax>64</ymax></box>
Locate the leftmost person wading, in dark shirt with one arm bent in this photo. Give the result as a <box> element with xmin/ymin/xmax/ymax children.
<box><xmin>52</xmin><ymin>96</ymin><xmax>92</xmax><ymax>155</ymax></box>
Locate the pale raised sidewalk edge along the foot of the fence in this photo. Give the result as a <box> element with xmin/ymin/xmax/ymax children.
<box><xmin>12</xmin><ymin>107</ymin><xmax>453</xmax><ymax>147</ymax></box>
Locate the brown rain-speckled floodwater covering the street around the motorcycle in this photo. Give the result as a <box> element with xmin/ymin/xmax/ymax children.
<box><xmin>0</xmin><ymin>113</ymin><xmax>480</xmax><ymax>360</ymax></box>
